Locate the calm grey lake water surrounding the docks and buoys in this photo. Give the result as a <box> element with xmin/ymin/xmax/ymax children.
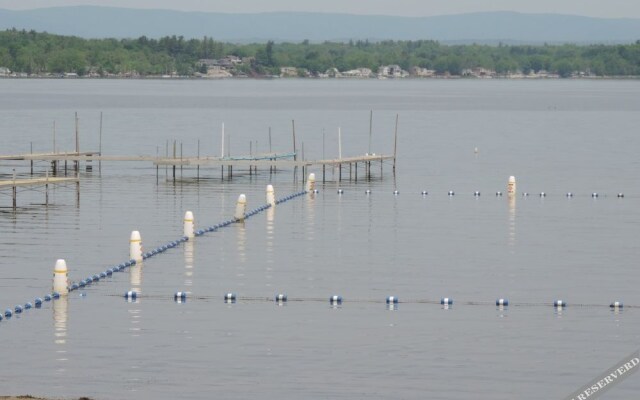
<box><xmin>0</xmin><ymin>80</ymin><xmax>640</xmax><ymax>400</ymax></box>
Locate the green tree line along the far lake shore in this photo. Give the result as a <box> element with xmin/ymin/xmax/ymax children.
<box><xmin>0</xmin><ymin>29</ymin><xmax>640</xmax><ymax>77</ymax></box>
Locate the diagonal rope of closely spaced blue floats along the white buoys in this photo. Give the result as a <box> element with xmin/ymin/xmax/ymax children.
<box><xmin>0</xmin><ymin>190</ymin><xmax>308</xmax><ymax>321</ymax></box>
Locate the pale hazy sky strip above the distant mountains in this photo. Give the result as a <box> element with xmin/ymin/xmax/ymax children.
<box><xmin>0</xmin><ymin>0</ymin><xmax>640</xmax><ymax>18</ymax></box>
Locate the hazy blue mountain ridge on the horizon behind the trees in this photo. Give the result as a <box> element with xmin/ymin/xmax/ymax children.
<box><xmin>0</xmin><ymin>6</ymin><xmax>640</xmax><ymax>44</ymax></box>
